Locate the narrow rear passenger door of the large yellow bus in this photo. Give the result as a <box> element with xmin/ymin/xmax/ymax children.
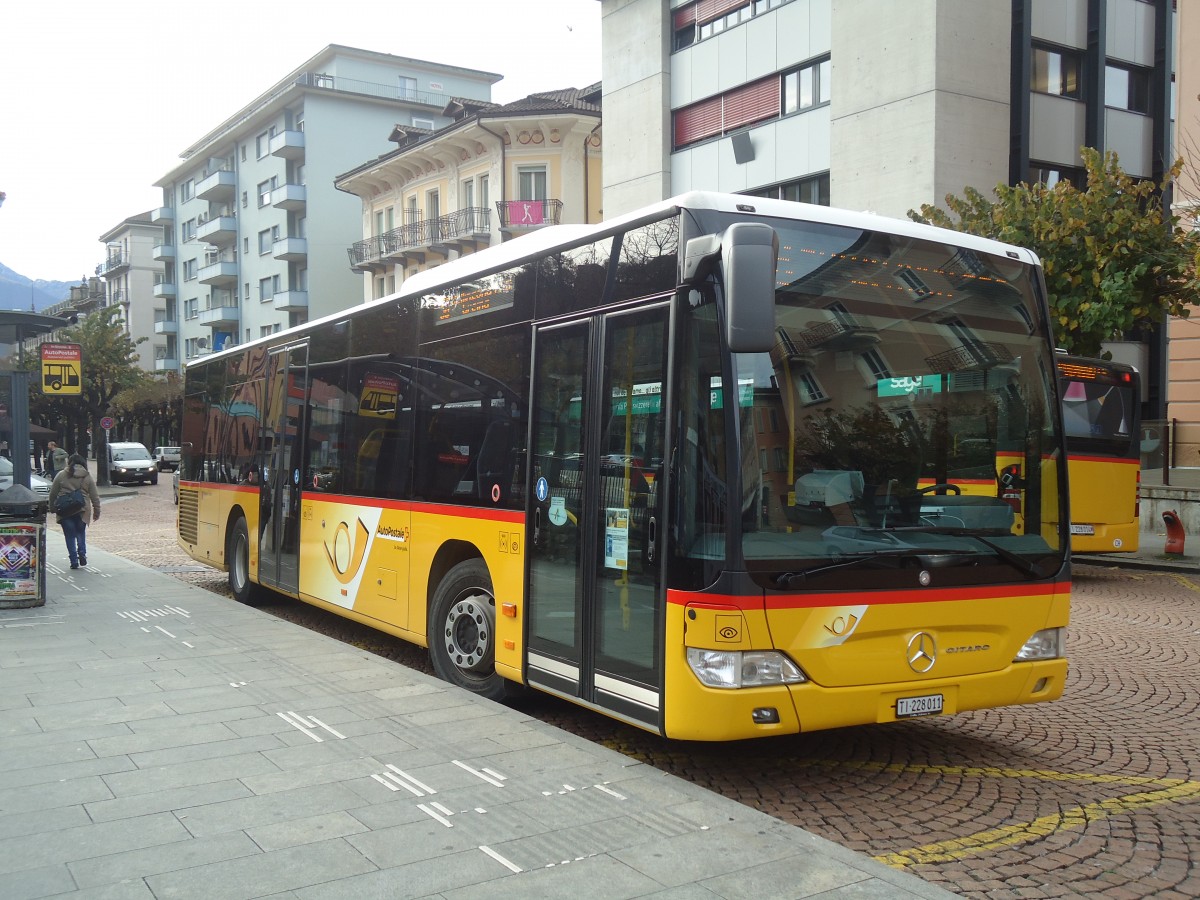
<box><xmin>258</xmin><ymin>343</ymin><xmax>308</xmax><ymax>594</ymax></box>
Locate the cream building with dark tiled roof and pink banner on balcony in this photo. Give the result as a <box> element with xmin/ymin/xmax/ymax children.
<box><xmin>336</xmin><ymin>84</ymin><xmax>602</xmax><ymax>300</ymax></box>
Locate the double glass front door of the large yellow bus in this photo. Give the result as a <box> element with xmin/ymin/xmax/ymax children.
<box><xmin>526</xmin><ymin>304</ymin><xmax>670</xmax><ymax>728</ymax></box>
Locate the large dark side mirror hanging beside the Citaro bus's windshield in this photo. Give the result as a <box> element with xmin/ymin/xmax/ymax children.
<box><xmin>721</xmin><ymin>222</ymin><xmax>779</xmax><ymax>353</ymax></box>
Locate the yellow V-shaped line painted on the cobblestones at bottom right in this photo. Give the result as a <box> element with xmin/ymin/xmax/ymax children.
<box><xmin>875</xmin><ymin>767</ymin><xmax>1200</xmax><ymax>869</ymax></box>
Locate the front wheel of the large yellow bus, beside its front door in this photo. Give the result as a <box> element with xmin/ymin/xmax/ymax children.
<box><xmin>430</xmin><ymin>559</ymin><xmax>505</xmax><ymax>700</ymax></box>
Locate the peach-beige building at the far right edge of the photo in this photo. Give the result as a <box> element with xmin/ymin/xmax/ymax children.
<box><xmin>1166</xmin><ymin>2</ymin><xmax>1200</xmax><ymax>467</ymax></box>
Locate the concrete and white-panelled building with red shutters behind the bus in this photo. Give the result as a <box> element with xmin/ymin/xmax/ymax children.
<box><xmin>601</xmin><ymin>0</ymin><xmax>1171</xmax><ymax>416</ymax></box>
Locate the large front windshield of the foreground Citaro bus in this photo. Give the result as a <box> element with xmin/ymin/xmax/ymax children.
<box><xmin>733</xmin><ymin>214</ymin><xmax>1066</xmax><ymax>589</ymax></box>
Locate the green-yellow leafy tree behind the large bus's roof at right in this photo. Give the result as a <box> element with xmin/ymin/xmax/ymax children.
<box><xmin>908</xmin><ymin>148</ymin><xmax>1200</xmax><ymax>356</ymax></box>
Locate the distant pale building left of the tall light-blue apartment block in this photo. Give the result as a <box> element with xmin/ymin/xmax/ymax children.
<box><xmin>92</xmin><ymin>211</ymin><xmax>167</xmax><ymax>372</ymax></box>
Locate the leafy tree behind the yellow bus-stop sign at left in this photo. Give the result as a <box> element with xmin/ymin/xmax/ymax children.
<box><xmin>31</xmin><ymin>306</ymin><xmax>149</xmax><ymax>484</ymax></box>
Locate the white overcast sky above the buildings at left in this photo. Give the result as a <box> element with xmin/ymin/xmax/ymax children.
<box><xmin>0</xmin><ymin>0</ymin><xmax>600</xmax><ymax>281</ymax></box>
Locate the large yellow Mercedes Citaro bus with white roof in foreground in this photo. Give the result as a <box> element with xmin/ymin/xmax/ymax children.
<box><xmin>179</xmin><ymin>193</ymin><xmax>1070</xmax><ymax>740</ymax></box>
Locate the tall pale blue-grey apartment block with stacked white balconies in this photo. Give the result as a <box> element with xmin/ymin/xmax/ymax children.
<box><xmin>150</xmin><ymin>44</ymin><xmax>500</xmax><ymax>370</ymax></box>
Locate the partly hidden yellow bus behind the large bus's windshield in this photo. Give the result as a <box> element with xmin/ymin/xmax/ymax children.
<box><xmin>1058</xmin><ymin>355</ymin><xmax>1141</xmax><ymax>553</ymax></box>
